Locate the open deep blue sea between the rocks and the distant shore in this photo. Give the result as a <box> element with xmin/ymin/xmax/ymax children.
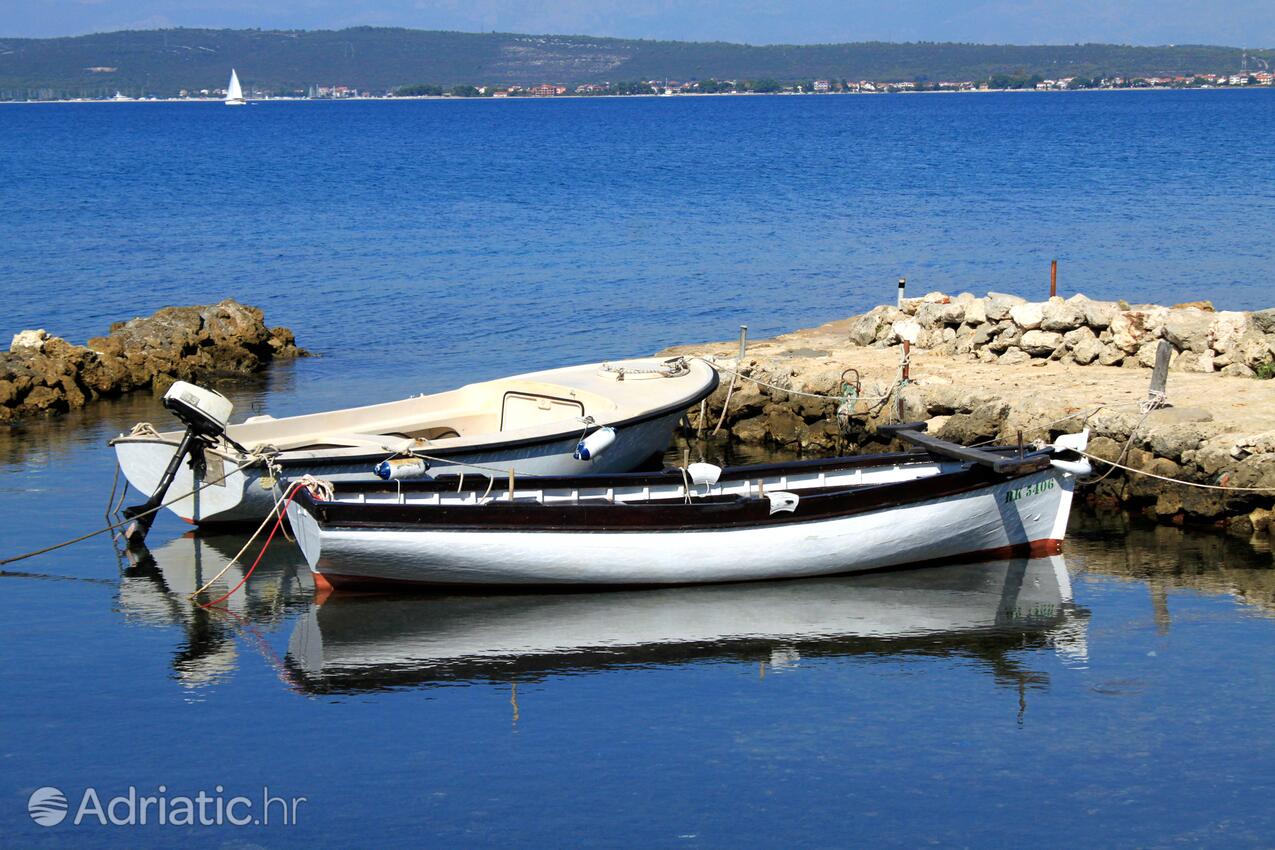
<box><xmin>0</xmin><ymin>90</ymin><xmax>1275</xmax><ymax>398</ymax></box>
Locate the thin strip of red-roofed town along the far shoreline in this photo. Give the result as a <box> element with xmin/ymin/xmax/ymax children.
<box><xmin>4</xmin><ymin>69</ymin><xmax>1275</xmax><ymax>103</ymax></box>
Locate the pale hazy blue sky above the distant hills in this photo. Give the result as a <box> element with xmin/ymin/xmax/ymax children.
<box><xmin>7</xmin><ymin>0</ymin><xmax>1275</xmax><ymax>47</ymax></box>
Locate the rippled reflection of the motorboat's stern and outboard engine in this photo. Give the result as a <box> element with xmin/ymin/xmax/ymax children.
<box><xmin>119</xmin><ymin>533</ymin><xmax>314</xmax><ymax>688</ymax></box>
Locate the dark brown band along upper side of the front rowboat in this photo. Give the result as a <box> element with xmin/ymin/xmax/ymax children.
<box><xmin>295</xmin><ymin>465</ymin><xmax>1055</xmax><ymax>533</ymax></box>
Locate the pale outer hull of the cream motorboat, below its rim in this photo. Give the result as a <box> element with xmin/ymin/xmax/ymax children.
<box><xmin>115</xmin><ymin>410</ymin><xmax>682</xmax><ymax>524</ymax></box>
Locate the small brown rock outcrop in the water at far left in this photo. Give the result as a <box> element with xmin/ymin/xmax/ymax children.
<box><xmin>0</xmin><ymin>299</ymin><xmax>306</xmax><ymax>422</ymax></box>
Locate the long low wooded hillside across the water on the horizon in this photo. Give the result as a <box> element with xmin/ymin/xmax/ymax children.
<box><xmin>0</xmin><ymin>27</ymin><xmax>1275</xmax><ymax>98</ymax></box>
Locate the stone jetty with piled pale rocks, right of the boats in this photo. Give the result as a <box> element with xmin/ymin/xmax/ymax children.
<box><xmin>668</xmin><ymin>293</ymin><xmax>1275</xmax><ymax>535</ymax></box>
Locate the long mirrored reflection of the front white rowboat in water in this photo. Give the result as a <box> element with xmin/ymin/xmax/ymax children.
<box><xmin>287</xmin><ymin>556</ymin><xmax>1088</xmax><ymax>693</ymax></box>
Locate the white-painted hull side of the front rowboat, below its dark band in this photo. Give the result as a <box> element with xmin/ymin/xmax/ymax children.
<box><xmin>289</xmin><ymin>468</ymin><xmax>1075</xmax><ymax>585</ymax></box>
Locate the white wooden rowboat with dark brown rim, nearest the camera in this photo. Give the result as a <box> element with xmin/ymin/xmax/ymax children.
<box><xmin>288</xmin><ymin>423</ymin><xmax>1089</xmax><ymax>587</ymax></box>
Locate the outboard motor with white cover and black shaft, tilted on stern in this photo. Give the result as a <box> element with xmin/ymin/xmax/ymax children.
<box><xmin>124</xmin><ymin>381</ymin><xmax>244</xmax><ymax>545</ymax></box>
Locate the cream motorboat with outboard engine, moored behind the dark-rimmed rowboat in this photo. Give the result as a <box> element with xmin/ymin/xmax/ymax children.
<box><xmin>111</xmin><ymin>358</ymin><xmax>718</xmax><ymax>525</ymax></box>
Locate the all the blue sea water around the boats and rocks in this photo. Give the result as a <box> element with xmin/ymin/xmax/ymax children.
<box><xmin>0</xmin><ymin>92</ymin><xmax>1275</xmax><ymax>847</ymax></box>
